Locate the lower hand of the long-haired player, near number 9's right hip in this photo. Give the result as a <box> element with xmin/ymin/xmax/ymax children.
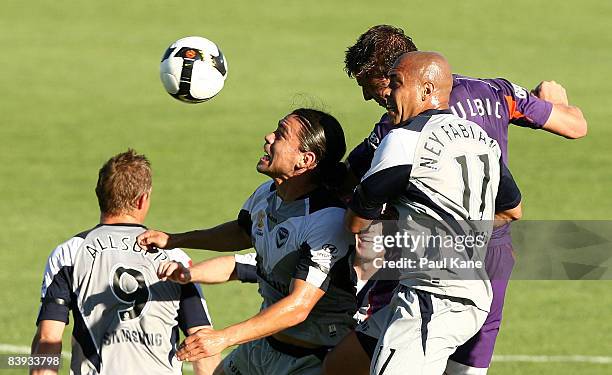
<box><xmin>176</xmin><ymin>328</ymin><xmax>230</xmax><ymax>362</ymax></box>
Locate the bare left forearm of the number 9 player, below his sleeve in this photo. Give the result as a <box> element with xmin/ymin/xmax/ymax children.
<box><xmin>30</xmin><ymin>320</ymin><xmax>66</xmax><ymax>375</ymax></box>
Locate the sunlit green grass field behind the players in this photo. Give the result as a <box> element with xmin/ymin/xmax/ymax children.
<box><xmin>0</xmin><ymin>0</ymin><xmax>612</xmax><ymax>374</ymax></box>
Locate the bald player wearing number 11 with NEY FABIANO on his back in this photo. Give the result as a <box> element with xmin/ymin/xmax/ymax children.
<box><xmin>347</xmin><ymin>52</ymin><xmax>520</xmax><ymax>374</ymax></box>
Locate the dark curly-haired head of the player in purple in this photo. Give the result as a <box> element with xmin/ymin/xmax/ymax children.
<box><xmin>344</xmin><ymin>25</ymin><xmax>417</xmax><ymax>107</ymax></box>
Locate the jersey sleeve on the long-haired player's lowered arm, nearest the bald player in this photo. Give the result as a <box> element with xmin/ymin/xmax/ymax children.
<box><xmin>293</xmin><ymin>208</ymin><xmax>354</xmax><ymax>292</ymax></box>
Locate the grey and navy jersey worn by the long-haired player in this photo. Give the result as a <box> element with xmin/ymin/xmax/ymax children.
<box><xmin>238</xmin><ymin>181</ymin><xmax>357</xmax><ymax>346</ymax></box>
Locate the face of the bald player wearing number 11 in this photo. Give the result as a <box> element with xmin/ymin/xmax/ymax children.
<box><xmin>387</xmin><ymin>68</ymin><xmax>419</xmax><ymax>125</ymax></box>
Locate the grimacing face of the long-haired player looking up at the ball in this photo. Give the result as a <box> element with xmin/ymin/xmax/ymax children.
<box><xmin>257</xmin><ymin>115</ymin><xmax>303</xmax><ymax>178</ymax></box>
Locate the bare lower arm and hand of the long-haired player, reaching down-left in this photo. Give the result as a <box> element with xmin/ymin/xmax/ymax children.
<box><xmin>176</xmin><ymin>279</ymin><xmax>325</xmax><ymax>361</ymax></box>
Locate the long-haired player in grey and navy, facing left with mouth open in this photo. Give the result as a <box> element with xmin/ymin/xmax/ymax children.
<box><xmin>139</xmin><ymin>109</ymin><xmax>356</xmax><ymax>375</ymax></box>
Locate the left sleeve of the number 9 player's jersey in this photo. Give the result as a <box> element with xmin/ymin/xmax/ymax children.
<box><xmin>36</xmin><ymin>237</ymin><xmax>83</xmax><ymax>325</ymax></box>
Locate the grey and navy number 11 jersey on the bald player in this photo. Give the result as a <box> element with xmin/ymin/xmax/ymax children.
<box><xmin>351</xmin><ymin>110</ymin><xmax>520</xmax><ymax>311</ymax></box>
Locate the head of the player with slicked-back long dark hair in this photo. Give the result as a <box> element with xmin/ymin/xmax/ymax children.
<box><xmin>257</xmin><ymin>108</ymin><xmax>346</xmax><ymax>189</ymax></box>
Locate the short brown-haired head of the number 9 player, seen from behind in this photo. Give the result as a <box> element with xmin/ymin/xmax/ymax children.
<box><xmin>96</xmin><ymin>149</ymin><xmax>152</xmax><ymax>221</ymax></box>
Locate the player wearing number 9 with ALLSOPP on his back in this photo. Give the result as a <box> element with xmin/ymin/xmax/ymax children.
<box><xmin>33</xmin><ymin>150</ymin><xmax>219</xmax><ymax>374</ymax></box>
